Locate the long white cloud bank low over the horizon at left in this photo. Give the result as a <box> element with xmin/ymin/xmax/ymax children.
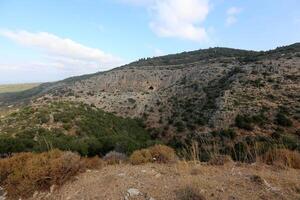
<box><xmin>0</xmin><ymin>30</ymin><xmax>123</xmax><ymax>80</ymax></box>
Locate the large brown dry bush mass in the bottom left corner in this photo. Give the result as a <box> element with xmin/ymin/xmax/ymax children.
<box><xmin>0</xmin><ymin>150</ymin><xmax>83</xmax><ymax>199</ymax></box>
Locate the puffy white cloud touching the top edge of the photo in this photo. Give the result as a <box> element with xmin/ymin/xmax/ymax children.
<box><xmin>121</xmin><ymin>0</ymin><xmax>210</xmax><ymax>42</ymax></box>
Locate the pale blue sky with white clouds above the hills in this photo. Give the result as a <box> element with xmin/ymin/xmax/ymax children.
<box><xmin>0</xmin><ymin>0</ymin><xmax>300</xmax><ymax>84</ymax></box>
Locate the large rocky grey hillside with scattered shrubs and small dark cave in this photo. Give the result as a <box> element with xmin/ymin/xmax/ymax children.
<box><xmin>0</xmin><ymin>43</ymin><xmax>300</xmax><ymax>155</ymax></box>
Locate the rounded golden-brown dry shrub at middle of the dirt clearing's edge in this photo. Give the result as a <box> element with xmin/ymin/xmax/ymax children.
<box><xmin>129</xmin><ymin>145</ymin><xmax>177</xmax><ymax>165</ymax></box>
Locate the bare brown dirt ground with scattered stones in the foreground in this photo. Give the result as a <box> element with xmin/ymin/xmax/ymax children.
<box><xmin>33</xmin><ymin>162</ymin><xmax>300</xmax><ymax>200</ymax></box>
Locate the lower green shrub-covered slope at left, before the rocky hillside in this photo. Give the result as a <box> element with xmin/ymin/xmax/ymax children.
<box><xmin>0</xmin><ymin>102</ymin><xmax>154</xmax><ymax>156</ymax></box>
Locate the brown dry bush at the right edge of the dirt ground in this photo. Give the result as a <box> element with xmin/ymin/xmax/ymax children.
<box><xmin>260</xmin><ymin>149</ymin><xmax>300</xmax><ymax>169</ymax></box>
